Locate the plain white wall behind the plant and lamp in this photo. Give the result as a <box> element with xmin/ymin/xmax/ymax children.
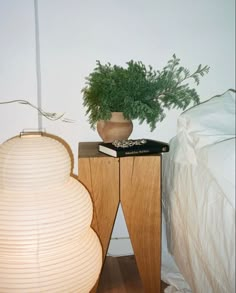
<box><xmin>0</xmin><ymin>0</ymin><xmax>235</xmax><ymax>254</ymax></box>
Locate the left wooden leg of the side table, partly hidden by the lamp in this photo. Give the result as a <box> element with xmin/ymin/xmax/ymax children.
<box><xmin>78</xmin><ymin>157</ymin><xmax>119</xmax><ymax>292</ymax></box>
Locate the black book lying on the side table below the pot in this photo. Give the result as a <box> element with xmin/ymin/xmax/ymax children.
<box><xmin>98</xmin><ymin>139</ymin><xmax>169</xmax><ymax>157</ymax></box>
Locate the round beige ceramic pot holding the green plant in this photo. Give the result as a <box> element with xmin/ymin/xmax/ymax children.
<box><xmin>97</xmin><ymin>112</ymin><xmax>133</xmax><ymax>142</ymax></box>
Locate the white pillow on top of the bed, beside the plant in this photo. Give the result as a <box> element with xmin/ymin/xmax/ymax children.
<box><xmin>177</xmin><ymin>90</ymin><xmax>235</xmax><ymax>149</ymax></box>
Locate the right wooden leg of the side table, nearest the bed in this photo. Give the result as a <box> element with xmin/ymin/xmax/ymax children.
<box><xmin>120</xmin><ymin>156</ymin><xmax>161</xmax><ymax>293</ymax></box>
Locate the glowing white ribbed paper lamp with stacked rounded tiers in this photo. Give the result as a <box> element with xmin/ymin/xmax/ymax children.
<box><xmin>0</xmin><ymin>135</ymin><xmax>102</xmax><ymax>293</ymax></box>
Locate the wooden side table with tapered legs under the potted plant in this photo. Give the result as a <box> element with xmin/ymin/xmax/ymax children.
<box><xmin>78</xmin><ymin>142</ymin><xmax>161</xmax><ymax>293</ymax></box>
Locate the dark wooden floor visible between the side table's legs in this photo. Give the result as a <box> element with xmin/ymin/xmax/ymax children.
<box><xmin>97</xmin><ymin>255</ymin><xmax>167</xmax><ymax>293</ymax></box>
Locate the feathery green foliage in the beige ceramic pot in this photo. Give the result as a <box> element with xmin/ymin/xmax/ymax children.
<box><xmin>82</xmin><ymin>55</ymin><xmax>209</xmax><ymax>131</ymax></box>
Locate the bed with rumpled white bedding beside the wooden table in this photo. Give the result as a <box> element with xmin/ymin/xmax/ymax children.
<box><xmin>162</xmin><ymin>90</ymin><xmax>235</xmax><ymax>293</ymax></box>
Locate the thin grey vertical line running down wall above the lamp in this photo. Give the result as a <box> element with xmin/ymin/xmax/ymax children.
<box><xmin>34</xmin><ymin>0</ymin><xmax>43</xmax><ymax>130</ymax></box>
